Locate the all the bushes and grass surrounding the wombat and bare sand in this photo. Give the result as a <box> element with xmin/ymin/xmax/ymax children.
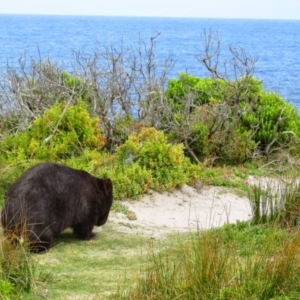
<box><xmin>0</xmin><ymin>33</ymin><xmax>300</xmax><ymax>300</ymax></box>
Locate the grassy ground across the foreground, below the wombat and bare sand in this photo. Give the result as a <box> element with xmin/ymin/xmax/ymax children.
<box><xmin>0</xmin><ymin>162</ymin><xmax>300</xmax><ymax>300</ymax></box>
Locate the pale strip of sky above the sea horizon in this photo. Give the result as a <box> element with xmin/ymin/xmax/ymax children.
<box><xmin>0</xmin><ymin>0</ymin><xmax>300</xmax><ymax>20</ymax></box>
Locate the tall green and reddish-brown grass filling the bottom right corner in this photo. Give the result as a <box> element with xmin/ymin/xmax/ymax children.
<box><xmin>114</xmin><ymin>223</ymin><xmax>300</xmax><ymax>300</ymax></box>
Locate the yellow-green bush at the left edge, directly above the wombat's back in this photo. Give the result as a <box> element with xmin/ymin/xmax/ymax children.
<box><xmin>0</xmin><ymin>100</ymin><xmax>104</xmax><ymax>160</ymax></box>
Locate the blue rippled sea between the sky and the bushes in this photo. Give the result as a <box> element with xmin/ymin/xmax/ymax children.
<box><xmin>0</xmin><ymin>15</ymin><xmax>300</xmax><ymax>109</ymax></box>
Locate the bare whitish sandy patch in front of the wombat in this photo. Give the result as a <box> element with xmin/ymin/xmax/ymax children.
<box><xmin>109</xmin><ymin>185</ymin><xmax>251</xmax><ymax>236</ymax></box>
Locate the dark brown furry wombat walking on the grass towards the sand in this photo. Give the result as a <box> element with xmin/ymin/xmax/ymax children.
<box><xmin>1</xmin><ymin>163</ymin><xmax>113</xmax><ymax>252</ymax></box>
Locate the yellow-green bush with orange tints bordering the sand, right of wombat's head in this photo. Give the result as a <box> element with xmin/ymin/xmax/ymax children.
<box><xmin>116</xmin><ymin>128</ymin><xmax>191</xmax><ymax>190</ymax></box>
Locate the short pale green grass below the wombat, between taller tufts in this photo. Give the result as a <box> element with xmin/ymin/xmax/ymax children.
<box><xmin>28</xmin><ymin>223</ymin><xmax>151</xmax><ymax>299</ymax></box>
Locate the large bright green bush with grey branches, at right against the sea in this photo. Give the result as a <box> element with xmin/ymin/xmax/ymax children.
<box><xmin>162</xmin><ymin>73</ymin><xmax>300</xmax><ymax>165</ymax></box>
